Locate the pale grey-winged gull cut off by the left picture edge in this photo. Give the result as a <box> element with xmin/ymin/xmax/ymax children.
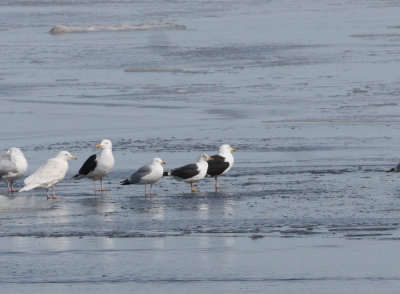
<box><xmin>0</xmin><ymin>147</ymin><xmax>28</xmax><ymax>193</ymax></box>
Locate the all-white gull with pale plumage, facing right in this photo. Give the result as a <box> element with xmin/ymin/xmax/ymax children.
<box><xmin>20</xmin><ymin>151</ymin><xmax>77</xmax><ymax>199</ymax></box>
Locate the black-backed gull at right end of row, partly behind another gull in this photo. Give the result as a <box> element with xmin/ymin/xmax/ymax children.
<box><xmin>207</xmin><ymin>144</ymin><xmax>236</xmax><ymax>191</ymax></box>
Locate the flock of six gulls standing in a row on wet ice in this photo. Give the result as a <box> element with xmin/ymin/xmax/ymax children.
<box><xmin>0</xmin><ymin>139</ymin><xmax>236</xmax><ymax>199</ymax></box>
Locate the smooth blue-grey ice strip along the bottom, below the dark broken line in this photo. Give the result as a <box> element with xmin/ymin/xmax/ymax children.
<box><xmin>0</xmin><ymin>235</ymin><xmax>400</xmax><ymax>293</ymax></box>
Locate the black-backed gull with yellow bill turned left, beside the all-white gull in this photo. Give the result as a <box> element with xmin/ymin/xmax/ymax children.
<box><xmin>73</xmin><ymin>139</ymin><xmax>114</xmax><ymax>192</ymax></box>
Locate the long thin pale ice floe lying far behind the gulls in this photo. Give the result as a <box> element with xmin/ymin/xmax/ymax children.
<box><xmin>49</xmin><ymin>22</ymin><xmax>186</xmax><ymax>35</ymax></box>
